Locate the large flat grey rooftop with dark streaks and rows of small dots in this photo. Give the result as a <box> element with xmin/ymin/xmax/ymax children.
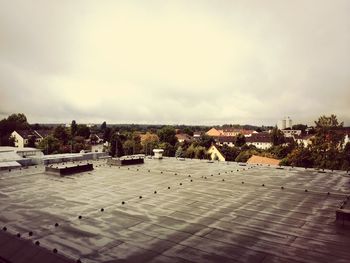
<box><xmin>0</xmin><ymin>158</ymin><xmax>350</xmax><ymax>263</ymax></box>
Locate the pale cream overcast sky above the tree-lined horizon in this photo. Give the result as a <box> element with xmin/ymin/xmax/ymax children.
<box><xmin>0</xmin><ymin>0</ymin><xmax>350</xmax><ymax>125</ymax></box>
